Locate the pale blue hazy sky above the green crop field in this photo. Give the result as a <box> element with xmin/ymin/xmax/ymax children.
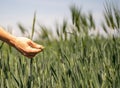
<box><xmin>0</xmin><ymin>0</ymin><xmax>120</xmax><ymax>34</ymax></box>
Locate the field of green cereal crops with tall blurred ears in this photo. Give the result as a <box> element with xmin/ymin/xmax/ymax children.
<box><xmin>0</xmin><ymin>4</ymin><xmax>120</xmax><ymax>88</ymax></box>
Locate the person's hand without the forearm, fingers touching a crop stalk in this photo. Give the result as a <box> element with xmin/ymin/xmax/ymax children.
<box><xmin>14</xmin><ymin>37</ymin><xmax>44</xmax><ymax>58</ymax></box>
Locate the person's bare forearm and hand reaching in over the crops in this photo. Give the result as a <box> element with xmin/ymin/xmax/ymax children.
<box><xmin>0</xmin><ymin>27</ymin><xmax>44</xmax><ymax>58</ymax></box>
